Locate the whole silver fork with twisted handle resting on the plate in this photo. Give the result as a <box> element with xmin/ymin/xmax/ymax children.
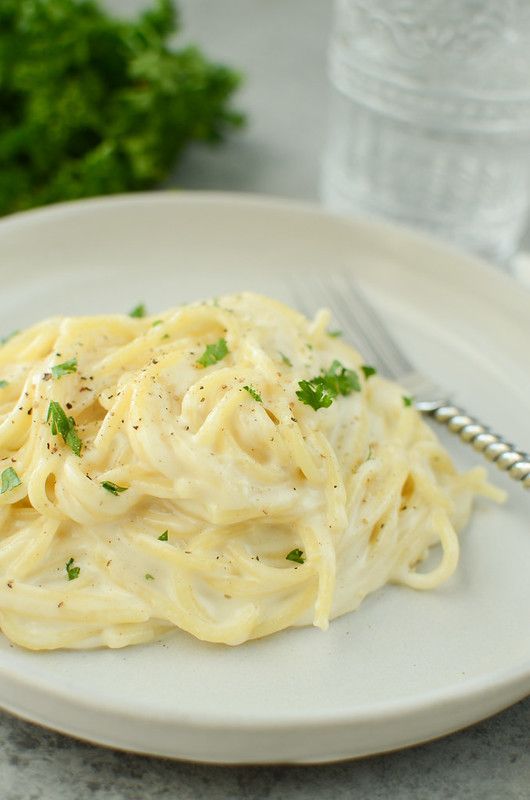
<box><xmin>293</xmin><ymin>273</ymin><xmax>530</xmax><ymax>489</ymax></box>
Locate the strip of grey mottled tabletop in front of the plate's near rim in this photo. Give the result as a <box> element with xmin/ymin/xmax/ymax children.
<box><xmin>0</xmin><ymin>699</ymin><xmax>530</xmax><ymax>800</ymax></box>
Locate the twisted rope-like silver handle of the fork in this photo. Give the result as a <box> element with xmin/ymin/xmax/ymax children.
<box><xmin>417</xmin><ymin>403</ymin><xmax>530</xmax><ymax>489</ymax></box>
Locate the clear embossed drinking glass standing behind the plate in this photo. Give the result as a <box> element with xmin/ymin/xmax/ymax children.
<box><xmin>322</xmin><ymin>0</ymin><xmax>530</xmax><ymax>263</ymax></box>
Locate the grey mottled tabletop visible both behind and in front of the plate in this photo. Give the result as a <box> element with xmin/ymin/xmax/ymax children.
<box><xmin>0</xmin><ymin>0</ymin><xmax>530</xmax><ymax>800</ymax></box>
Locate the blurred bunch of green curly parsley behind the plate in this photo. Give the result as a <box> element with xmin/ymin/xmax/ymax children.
<box><xmin>0</xmin><ymin>0</ymin><xmax>243</xmax><ymax>214</ymax></box>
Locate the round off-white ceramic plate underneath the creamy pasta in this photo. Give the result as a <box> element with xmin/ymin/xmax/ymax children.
<box><xmin>0</xmin><ymin>193</ymin><xmax>530</xmax><ymax>763</ymax></box>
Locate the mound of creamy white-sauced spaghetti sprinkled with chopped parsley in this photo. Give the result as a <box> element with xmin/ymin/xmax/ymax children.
<box><xmin>0</xmin><ymin>293</ymin><xmax>501</xmax><ymax>650</ymax></box>
